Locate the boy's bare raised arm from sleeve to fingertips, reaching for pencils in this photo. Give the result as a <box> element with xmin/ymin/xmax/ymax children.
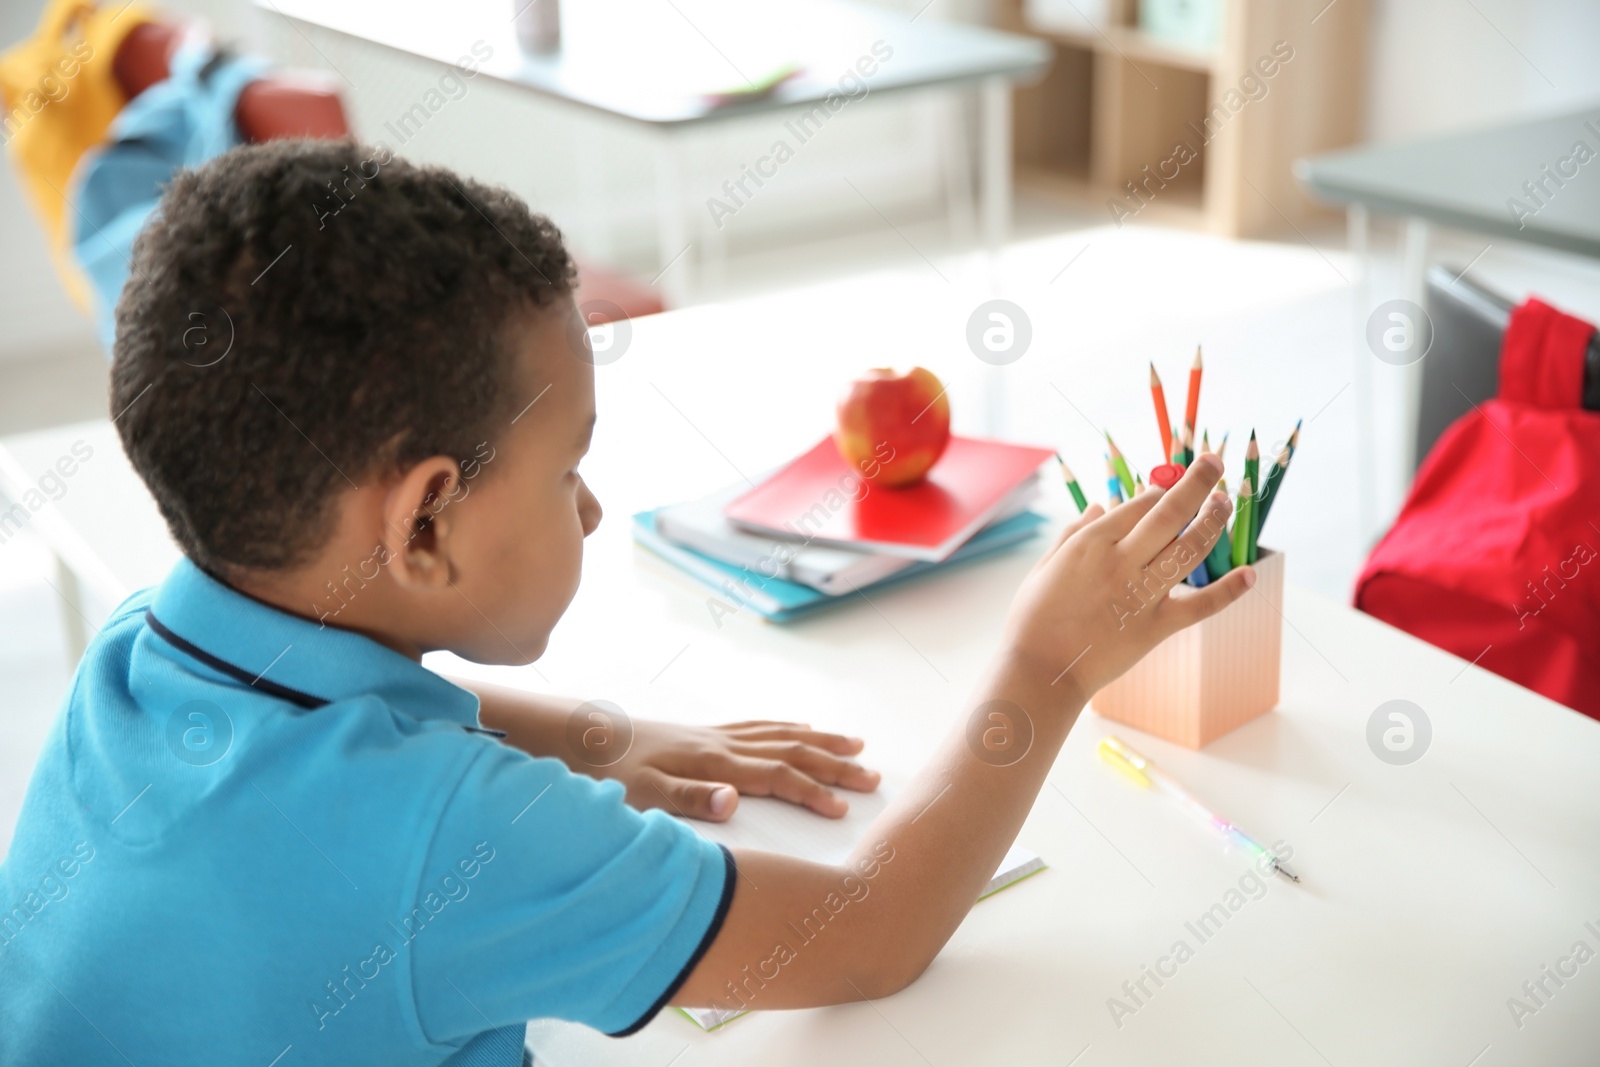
<box><xmin>674</xmin><ymin>454</ymin><xmax>1253</xmax><ymax>1008</ymax></box>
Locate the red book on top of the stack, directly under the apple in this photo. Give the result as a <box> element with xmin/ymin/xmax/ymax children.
<box><xmin>725</xmin><ymin>437</ymin><xmax>1054</xmax><ymax>563</ymax></box>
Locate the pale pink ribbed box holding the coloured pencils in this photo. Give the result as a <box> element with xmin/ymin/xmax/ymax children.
<box><xmin>1090</xmin><ymin>549</ymin><xmax>1283</xmax><ymax>749</ymax></box>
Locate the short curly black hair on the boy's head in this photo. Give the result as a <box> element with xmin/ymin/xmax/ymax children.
<box><xmin>110</xmin><ymin>141</ymin><xmax>576</xmax><ymax>574</ymax></box>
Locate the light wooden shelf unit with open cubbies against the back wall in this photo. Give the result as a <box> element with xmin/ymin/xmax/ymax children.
<box><xmin>995</xmin><ymin>0</ymin><xmax>1368</xmax><ymax>237</ymax></box>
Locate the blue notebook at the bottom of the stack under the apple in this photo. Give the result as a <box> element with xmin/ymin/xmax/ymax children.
<box><xmin>634</xmin><ymin>509</ymin><xmax>1048</xmax><ymax>622</ymax></box>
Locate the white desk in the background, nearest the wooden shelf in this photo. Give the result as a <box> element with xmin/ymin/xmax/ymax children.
<box><xmin>258</xmin><ymin>0</ymin><xmax>1051</xmax><ymax>306</ymax></box>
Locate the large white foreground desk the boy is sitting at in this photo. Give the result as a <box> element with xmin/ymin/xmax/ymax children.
<box><xmin>11</xmin><ymin>262</ymin><xmax>1600</xmax><ymax>1067</ymax></box>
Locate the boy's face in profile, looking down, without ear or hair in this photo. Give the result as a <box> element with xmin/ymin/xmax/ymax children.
<box><xmin>442</xmin><ymin>299</ymin><xmax>600</xmax><ymax>664</ymax></box>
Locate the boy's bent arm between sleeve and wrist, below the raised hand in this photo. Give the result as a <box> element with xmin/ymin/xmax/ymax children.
<box><xmin>675</xmin><ymin>659</ymin><xmax>1085</xmax><ymax>1008</ymax></box>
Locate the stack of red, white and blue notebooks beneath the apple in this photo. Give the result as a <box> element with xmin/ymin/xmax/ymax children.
<box><xmin>634</xmin><ymin>437</ymin><xmax>1051</xmax><ymax>622</ymax></box>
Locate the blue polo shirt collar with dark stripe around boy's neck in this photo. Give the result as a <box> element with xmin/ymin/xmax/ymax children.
<box><xmin>149</xmin><ymin>558</ymin><xmax>478</xmax><ymax>728</ymax></box>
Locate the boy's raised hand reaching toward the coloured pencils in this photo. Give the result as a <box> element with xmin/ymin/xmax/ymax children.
<box><xmin>1006</xmin><ymin>453</ymin><xmax>1256</xmax><ymax>704</ymax></box>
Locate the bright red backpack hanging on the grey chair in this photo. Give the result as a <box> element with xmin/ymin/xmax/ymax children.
<box><xmin>1355</xmin><ymin>299</ymin><xmax>1600</xmax><ymax>718</ymax></box>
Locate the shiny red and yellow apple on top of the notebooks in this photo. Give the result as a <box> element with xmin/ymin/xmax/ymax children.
<box><xmin>834</xmin><ymin>366</ymin><xmax>950</xmax><ymax>490</ymax></box>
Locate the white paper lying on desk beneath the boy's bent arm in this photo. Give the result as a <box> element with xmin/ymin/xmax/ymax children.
<box><xmin>680</xmin><ymin>787</ymin><xmax>1045</xmax><ymax>1030</ymax></box>
